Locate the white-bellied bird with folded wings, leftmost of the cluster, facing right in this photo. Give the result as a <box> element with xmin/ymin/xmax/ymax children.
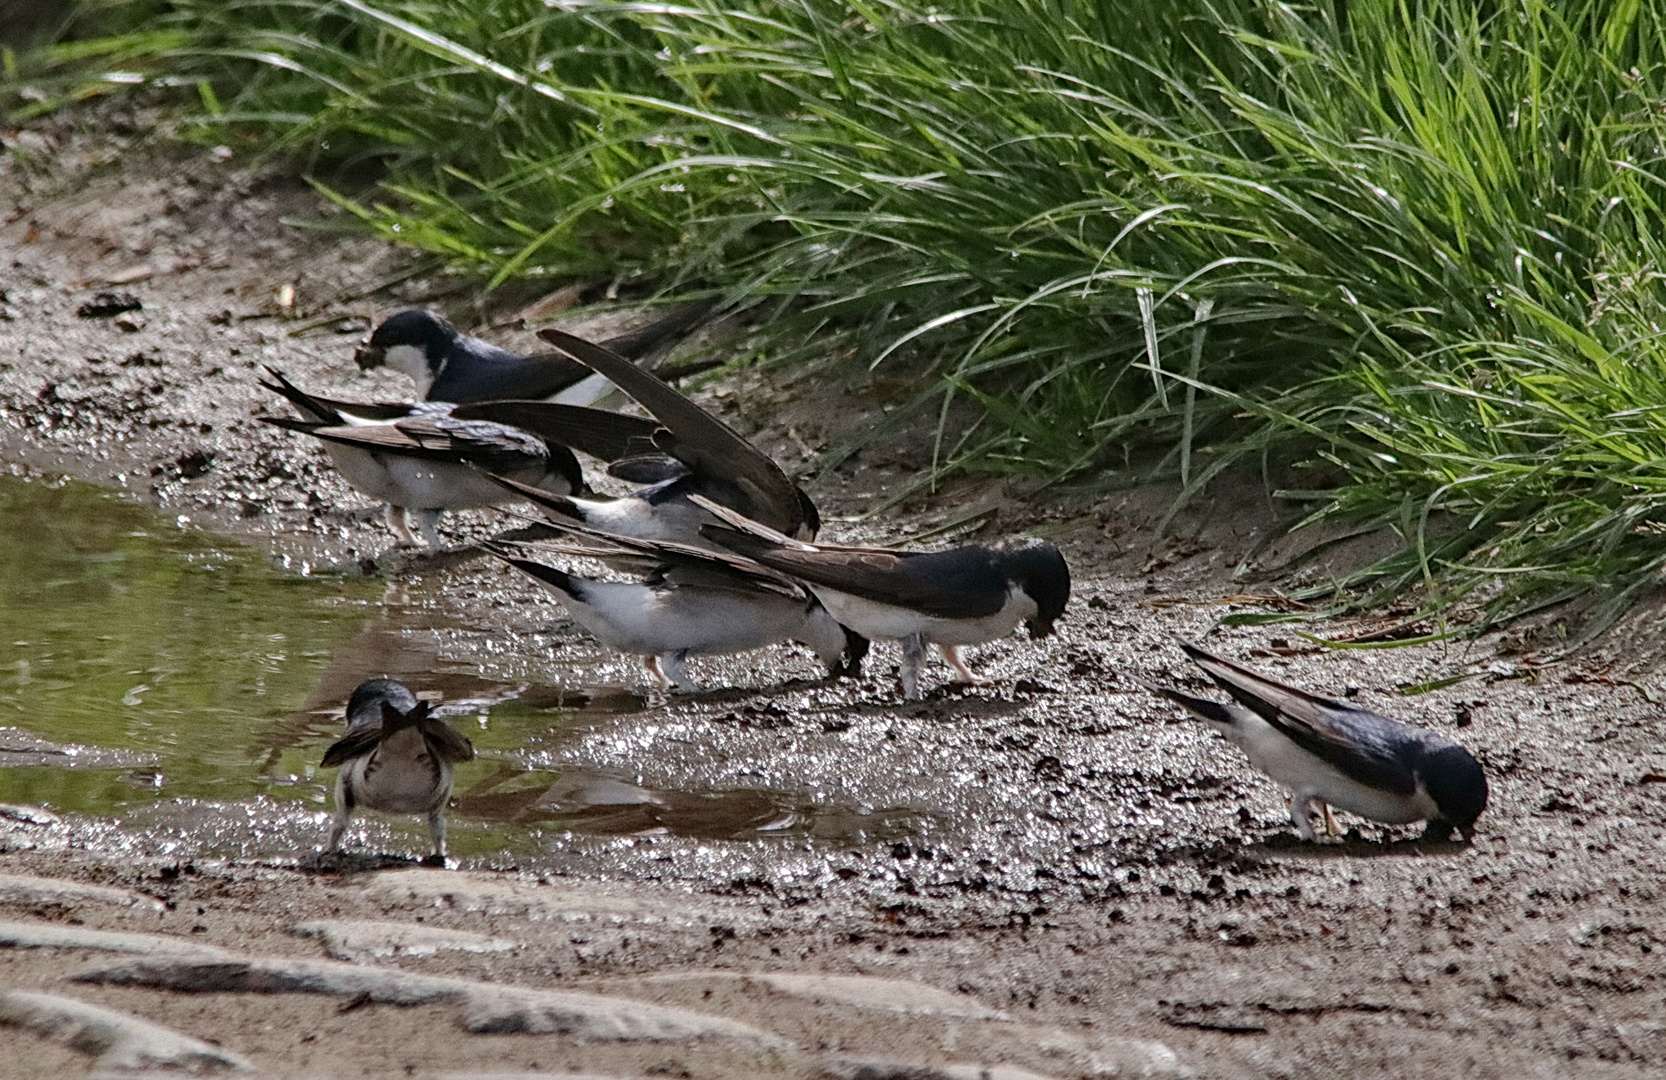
<box><xmin>260</xmin><ymin>368</ymin><xmax>586</xmax><ymax>548</ymax></box>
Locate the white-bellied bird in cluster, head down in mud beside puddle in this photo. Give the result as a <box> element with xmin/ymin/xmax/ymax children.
<box><xmin>483</xmin><ymin>528</ymin><xmax>868</xmax><ymax>692</ymax></box>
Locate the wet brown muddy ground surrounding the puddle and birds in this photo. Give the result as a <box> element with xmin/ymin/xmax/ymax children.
<box><xmin>0</xmin><ymin>101</ymin><xmax>1666</xmax><ymax>1078</ymax></box>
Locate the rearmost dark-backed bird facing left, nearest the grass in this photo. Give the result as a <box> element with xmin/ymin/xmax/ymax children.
<box><xmin>353</xmin><ymin>303</ymin><xmax>711</xmax><ymax>405</ymax></box>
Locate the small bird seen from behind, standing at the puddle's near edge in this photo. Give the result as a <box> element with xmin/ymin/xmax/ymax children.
<box><xmin>323</xmin><ymin>678</ymin><xmax>475</xmax><ymax>863</ymax></box>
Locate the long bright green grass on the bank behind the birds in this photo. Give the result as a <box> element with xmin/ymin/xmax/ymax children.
<box><xmin>16</xmin><ymin>0</ymin><xmax>1666</xmax><ymax>633</ymax></box>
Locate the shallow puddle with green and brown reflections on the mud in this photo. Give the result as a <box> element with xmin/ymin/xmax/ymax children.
<box><xmin>0</xmin><ymin>477</ymin><xmax>912</xmax><ymax>857</ymax></box>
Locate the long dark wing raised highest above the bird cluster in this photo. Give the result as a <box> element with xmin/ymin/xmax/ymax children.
<box><xmin>538</xmin><ymin>330</ymin><xmax>808</xmax><ymax>535</ymax></box>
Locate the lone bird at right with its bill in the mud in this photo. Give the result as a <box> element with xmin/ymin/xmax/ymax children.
<box><xmin>1151</xmin><ymin>642</ymin><xmax>1486</xmax><ymax>840</ymax></box>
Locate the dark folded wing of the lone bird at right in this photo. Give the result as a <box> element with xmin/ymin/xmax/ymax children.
<box><xmin>1180</xmin><ymin>642</ymin><xmax>1424</xmax><ymax>795</ymax></box>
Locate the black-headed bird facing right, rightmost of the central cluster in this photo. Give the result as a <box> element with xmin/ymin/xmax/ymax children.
<box><xmin>696</xmin><ymin>498</ymin><xmax>1070</xmax><ymax>700</ymax></box>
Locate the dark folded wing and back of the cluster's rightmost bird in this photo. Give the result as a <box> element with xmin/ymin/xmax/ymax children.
<box><xmin>700</xmin><ymin>525</ymin><xmax>1010</xmax><ymax>618</ymax></box>
